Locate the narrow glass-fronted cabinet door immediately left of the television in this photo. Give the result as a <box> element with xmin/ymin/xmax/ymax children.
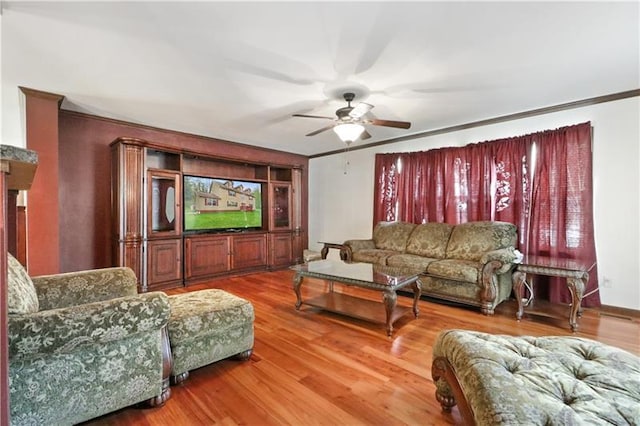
<box><xmin>147</xmin><ymin>171</ymin><xmax>182</xmax><ymax>235</ymax></box>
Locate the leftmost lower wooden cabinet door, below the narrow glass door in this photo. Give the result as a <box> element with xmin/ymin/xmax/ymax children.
<box><xmin>147</xmin><ymin>238</ymin><xmax>182</xmax><ymax>287</ymax></box>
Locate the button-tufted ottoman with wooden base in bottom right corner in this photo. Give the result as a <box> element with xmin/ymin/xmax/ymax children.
<box><xmin>431</xmin><ymin>330</ymin><xmax>640</xmax><ymax>425</ymax></box>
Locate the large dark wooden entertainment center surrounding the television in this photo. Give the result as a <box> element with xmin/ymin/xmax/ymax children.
<box><xmin>110</xmin><ymin>137</ymin><xmax>306</xmax><ymax>291</ymax></box>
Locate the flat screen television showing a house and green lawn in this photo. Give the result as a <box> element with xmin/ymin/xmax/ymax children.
<box><xmin>183</xmin><ymin>175</ymin><xmax>262</xmax><ymax>232</ymax></box>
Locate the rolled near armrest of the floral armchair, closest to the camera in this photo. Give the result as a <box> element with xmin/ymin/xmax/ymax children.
<box><xmin>8</xmin><ymin>292</ymin><xmax>170</xmax><ymax>359</ymax></box>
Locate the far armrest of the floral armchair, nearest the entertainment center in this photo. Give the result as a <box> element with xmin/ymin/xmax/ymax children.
<box><xmin>31</xmin><ymin>267</ymin><xmax>138</xmax><ymax>311</ymax></box>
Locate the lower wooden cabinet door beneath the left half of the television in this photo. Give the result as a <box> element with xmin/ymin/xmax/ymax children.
<box><xmin>185</xmin><ymin>236</ymin><xmax>231</xmax><ymax>279</ymax></box>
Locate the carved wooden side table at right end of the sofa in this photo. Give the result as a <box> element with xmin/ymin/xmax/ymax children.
<box><xmin>512</xmin><ymin>256</ymin><xmax>598</xmax><ymax>332</ymax></box>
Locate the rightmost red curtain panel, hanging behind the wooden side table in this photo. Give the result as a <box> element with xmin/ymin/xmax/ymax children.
<box><xmin>528</xmin><ymin>123</ymin><xmax>600</xmax><ymax>307</ymax></box>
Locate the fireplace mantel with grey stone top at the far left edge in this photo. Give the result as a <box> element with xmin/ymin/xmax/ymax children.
<box><xmin>0</xmin><ymin>145</ymin><xmax>38</xmax><ymax>425</ymax></box>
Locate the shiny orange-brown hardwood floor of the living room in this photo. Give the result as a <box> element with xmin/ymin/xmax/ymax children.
<box><xmin>87</xmin><ymin>271</ymin><xmax>640</xmax><ymax>426</ymax></box>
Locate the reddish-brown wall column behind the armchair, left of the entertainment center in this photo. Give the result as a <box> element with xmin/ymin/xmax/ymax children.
<box><xmin>20</xmin><ymin>87</ymin><xmax>64</xmax><ymax>275</ymax></box>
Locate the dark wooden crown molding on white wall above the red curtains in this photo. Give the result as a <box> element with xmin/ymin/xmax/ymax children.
<box><xmin>309</xmin><ymin>89</ymin><xmax>640</xmax><ymax>159</ymax></box>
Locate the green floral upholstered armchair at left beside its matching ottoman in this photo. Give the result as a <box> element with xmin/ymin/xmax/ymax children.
<box><xmin>8</xmin><ymin>255</ymin><xmax>171</xmax><ymax>425</ymax></box>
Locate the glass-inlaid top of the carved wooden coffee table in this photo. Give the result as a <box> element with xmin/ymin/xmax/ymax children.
<box><xmin>291</xmin><ymin>259</ymin><xmax>418</xmax><ymax>287</ymax></box>
